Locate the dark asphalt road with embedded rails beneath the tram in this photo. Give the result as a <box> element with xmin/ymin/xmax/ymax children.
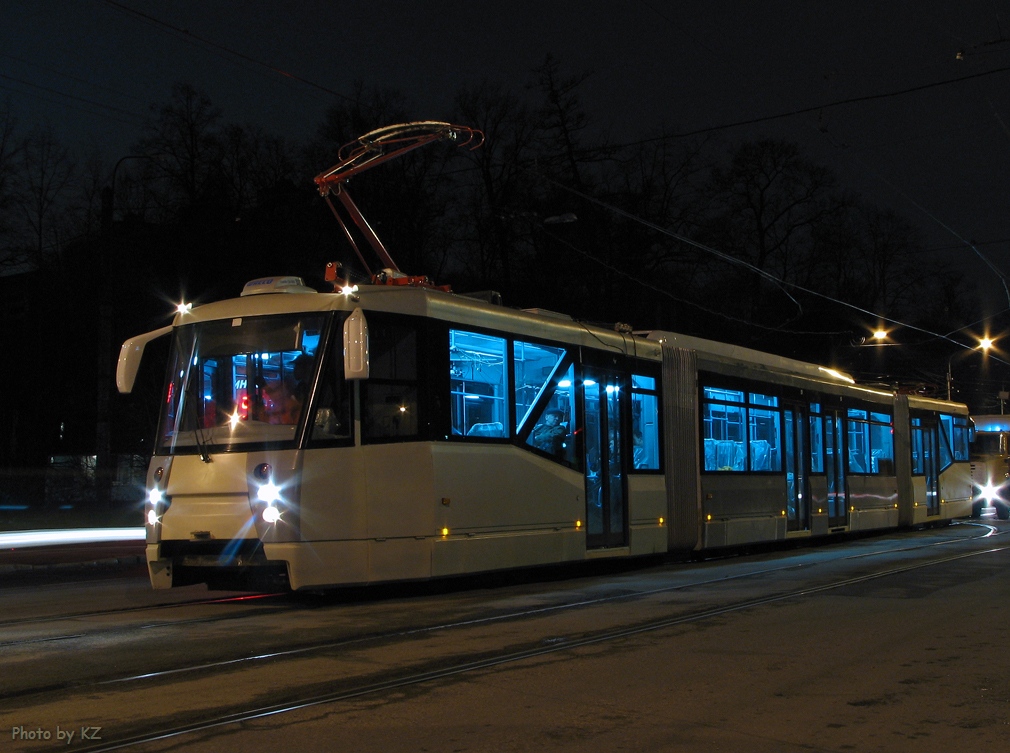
<box><xmin>0</xmin><ymin>523</ymin><xmax>1010</xmax><ymax>753</ymax></box>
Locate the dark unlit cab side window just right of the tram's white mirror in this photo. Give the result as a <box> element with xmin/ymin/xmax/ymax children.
<box><xmin>362</xmin><ymin>317</ymin><xmax>419</xmax><ymax>441</ymax></box>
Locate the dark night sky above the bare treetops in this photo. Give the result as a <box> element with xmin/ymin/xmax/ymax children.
<box><xmin>0</xmin><ymin>0</ymin><xmax>1010</xmax><ymax>296</ymax></box>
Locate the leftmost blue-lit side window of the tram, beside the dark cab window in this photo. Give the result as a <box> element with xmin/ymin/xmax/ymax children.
<box><xmin>448</xmin><ymin>329</ymin><xmax>509</xmax><ymax>437</ymax></box>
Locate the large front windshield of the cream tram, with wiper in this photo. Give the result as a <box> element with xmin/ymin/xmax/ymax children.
<box><xmin>158</xmin><ymin>314</ymin><xmax>325</xmax><ymax>454</ymax></box>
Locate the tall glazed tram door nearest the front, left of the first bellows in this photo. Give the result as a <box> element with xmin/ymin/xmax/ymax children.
<box><xmin>583</xmin><ymin>366</ymin><xmax>627</xmax><ymax>548</ymax></box>
